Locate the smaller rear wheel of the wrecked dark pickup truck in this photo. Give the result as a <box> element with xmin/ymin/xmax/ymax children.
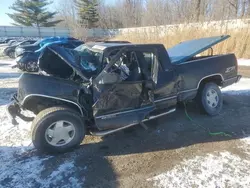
<box><xmin>197</xmin><ymin>82</ymin><xmax>223</xmax><ymax>116</ymax></box>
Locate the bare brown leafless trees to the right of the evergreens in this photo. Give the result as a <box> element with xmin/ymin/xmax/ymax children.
<box><xmin>98</xmin><ymin>0</ymin><xmax>250</xmax><ymax>28</ymax></box>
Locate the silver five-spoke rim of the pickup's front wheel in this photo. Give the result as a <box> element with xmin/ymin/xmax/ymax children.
<box><xmin>45</xmin><ymin>121</ymin><xmax>75</xmax><ymax>146</ymax></box>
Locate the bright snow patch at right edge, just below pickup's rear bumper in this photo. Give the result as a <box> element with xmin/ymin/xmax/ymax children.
<box><xmin>222</xmin><ymin>78</ymin><xmax>250</xmax><ymax>95</ymax></box>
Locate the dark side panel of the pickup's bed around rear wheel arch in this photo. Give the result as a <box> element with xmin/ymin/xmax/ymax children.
<box><xmin>174</xmin><ymin>54</ymin><xmax>238</xmax><ymax>101</ymax></box>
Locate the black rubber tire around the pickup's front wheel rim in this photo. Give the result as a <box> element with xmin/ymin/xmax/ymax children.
<box><xmin>31</xmin><ymin>107</ymin><xmax>86</xmax><ymax>153</ymax></box>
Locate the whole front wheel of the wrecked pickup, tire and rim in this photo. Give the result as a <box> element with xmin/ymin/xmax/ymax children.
<box><xmin>32</xmin><ymin>107</ymin><xmax>85</xmax><ymax>153</ymax></box>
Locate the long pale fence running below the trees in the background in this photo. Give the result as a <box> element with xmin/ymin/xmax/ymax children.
<box><xmin>0</xmin><ymin>19</ymin><xmax>250</xmax><ymax>38</ymax></box>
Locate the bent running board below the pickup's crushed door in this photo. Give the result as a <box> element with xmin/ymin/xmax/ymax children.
<box><xmin>90</xmin><ymin>108</ymin><xmax>176</xmax><ymax>136</ymax></box>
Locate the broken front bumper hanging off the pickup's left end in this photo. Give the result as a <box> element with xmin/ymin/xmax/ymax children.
<box><xmin>6</xmin><ymin>95</ymin><xmax>34</xmax><ymax>125</ymax></box>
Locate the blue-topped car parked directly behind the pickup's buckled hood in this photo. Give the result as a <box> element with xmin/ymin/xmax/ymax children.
<box><xmin>15</xmin><ymin>39</ymin><xmax>83</xmax><ymax>72</ymax></box>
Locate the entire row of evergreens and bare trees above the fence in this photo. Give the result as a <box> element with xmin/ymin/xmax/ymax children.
<box><xmin>8</xmin><ymin>0</ymin><xmax>250</xmax><ymax>29</ymax></box>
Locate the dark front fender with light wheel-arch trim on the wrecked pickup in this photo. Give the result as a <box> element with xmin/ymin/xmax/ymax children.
<box><xmin>17</xmin><ymin>73</ymin><xmax>82</xmax><ymax>112</ymax></box>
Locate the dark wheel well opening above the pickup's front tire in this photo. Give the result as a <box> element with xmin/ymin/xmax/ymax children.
<box><xmin>22</xmin><ymin>96</ymin><xmax>83</xmax><ymax>115</ymax></box>
